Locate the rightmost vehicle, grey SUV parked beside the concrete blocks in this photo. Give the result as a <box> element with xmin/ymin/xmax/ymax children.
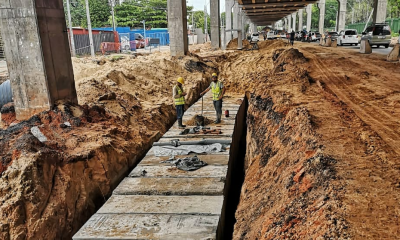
<box><xmin>361</xmin><ymin>23</ymin><xmax>392</xmax><ymax>48</ymax></box>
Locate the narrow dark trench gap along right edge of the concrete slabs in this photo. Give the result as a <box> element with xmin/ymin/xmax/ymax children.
<box><xmin>217</xmin><ymin>96</ymin><xmax>249</xmax><ymax>240</ymax></box>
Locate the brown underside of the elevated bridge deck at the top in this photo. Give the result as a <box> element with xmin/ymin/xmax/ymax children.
<box><xmin>238</xmin><ymin>0</ymin><xmax>317</xmax><ymax>25</ymax></box>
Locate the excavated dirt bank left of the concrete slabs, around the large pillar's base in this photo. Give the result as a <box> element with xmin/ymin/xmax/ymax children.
<box><xmin>0</xmin><ymin>53</ymin><xmax>216</xmax><ymax>239</ymax></box>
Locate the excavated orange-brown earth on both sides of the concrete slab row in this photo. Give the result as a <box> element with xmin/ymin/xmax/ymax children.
<box><xmin>0</xmin><ymin>40</ymin><xmax>400</xmax><ymax>240</ymax></box>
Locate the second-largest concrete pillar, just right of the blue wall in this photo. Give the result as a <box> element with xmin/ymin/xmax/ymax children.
<box><xmin>167</xmin><ymin>0</ymin><xmax>189</xmax><ymax>56</ymax></box>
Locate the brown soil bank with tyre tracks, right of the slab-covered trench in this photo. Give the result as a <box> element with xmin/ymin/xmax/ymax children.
<box><xmin>203</xmin><ymin>41</ymin><xmax>400</xmax><ymax>239</ymax></box>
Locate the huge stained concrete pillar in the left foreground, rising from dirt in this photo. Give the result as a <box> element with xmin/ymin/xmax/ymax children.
<box><xmin>0</xmin><ymin>0</ymin><xmax>78</xmax><ymax>120</ymax></box>
